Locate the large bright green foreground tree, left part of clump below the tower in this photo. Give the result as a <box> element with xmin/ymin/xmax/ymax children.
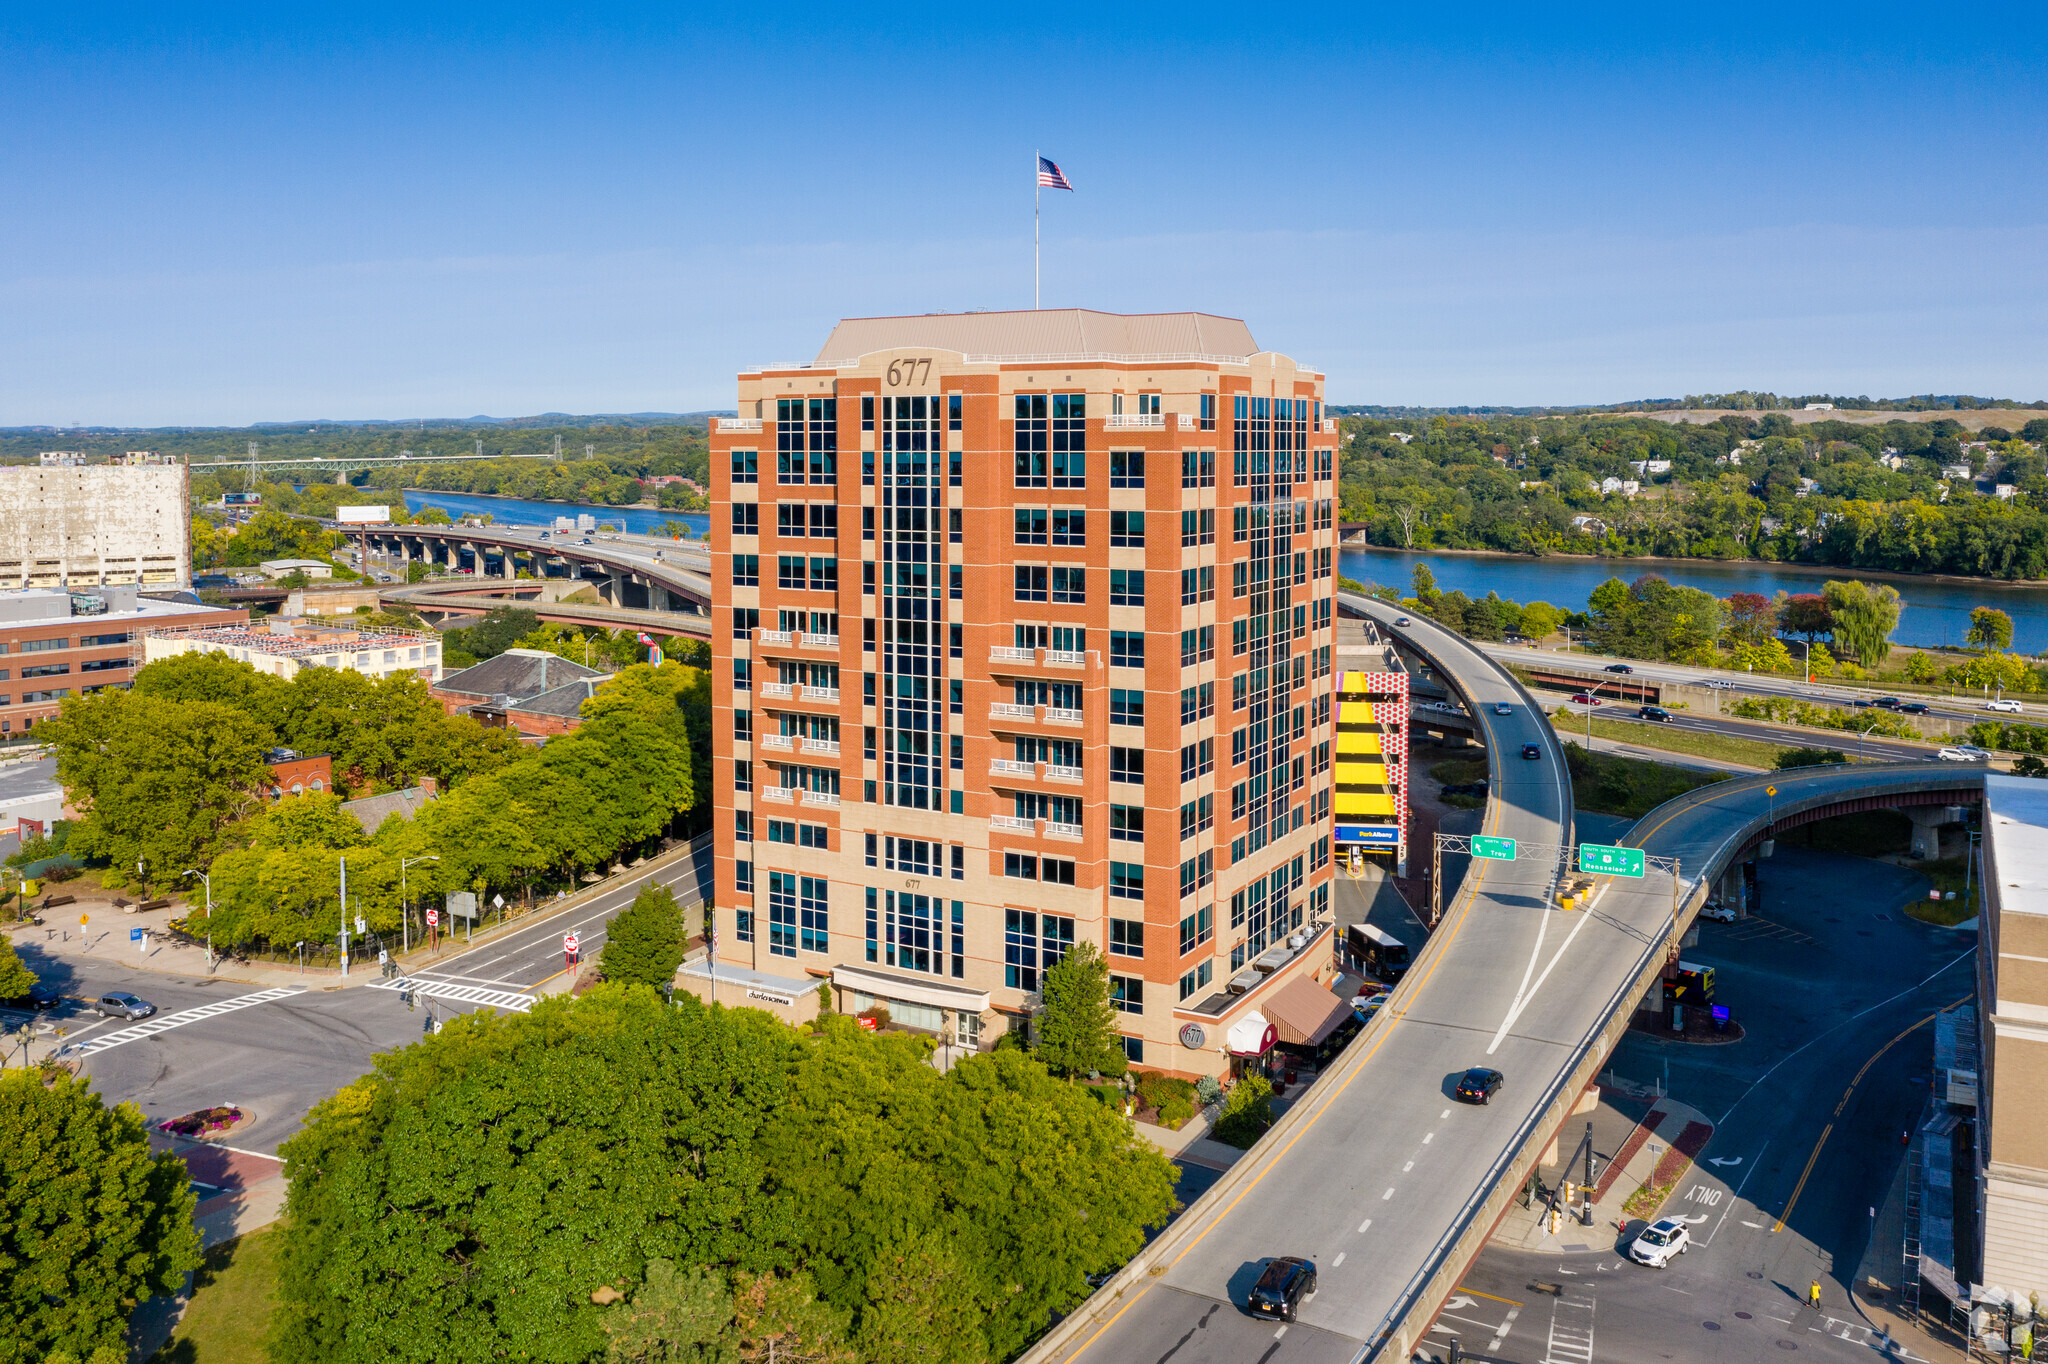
<box><xmin>272</xmin><ymin>985</ymin><xmax>795</xmax><ymax>1364</ymax></box>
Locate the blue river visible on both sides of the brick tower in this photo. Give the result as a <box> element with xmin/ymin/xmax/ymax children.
<box><xmin>406</xmin><ymin>489</ymin><xmax>2048</xmax><ymax>653</ymax></box>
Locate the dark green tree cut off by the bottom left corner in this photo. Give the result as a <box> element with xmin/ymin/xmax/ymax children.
<box><xmin>0</xmin><ymin>1071</ymin><xmax>199</xmax><ymax>1364</ymax></box>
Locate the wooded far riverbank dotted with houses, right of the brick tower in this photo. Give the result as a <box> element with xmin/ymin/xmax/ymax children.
<box><xmin>1339</xmin><ymin>412</ymin><xmax>2048</xmax><ymax>580</ymax></box>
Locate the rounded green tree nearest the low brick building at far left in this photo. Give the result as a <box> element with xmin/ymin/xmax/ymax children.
<box><xmin>39</xmin><ymin>692</ymin><xmax>272</xmax><ymax>885</ymax></box>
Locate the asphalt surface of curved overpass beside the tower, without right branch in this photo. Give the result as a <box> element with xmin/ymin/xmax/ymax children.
<box><xmin>1061</xmin><ymin>604</ymin><xmax>1593</xmax><ymax>1364</ymax></box>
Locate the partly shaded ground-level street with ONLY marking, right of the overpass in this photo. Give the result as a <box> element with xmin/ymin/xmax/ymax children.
<box><xmin>1458</xmin><ymin>846</ymin><xmax>1974</xmax><ymax>1364</ymax></box>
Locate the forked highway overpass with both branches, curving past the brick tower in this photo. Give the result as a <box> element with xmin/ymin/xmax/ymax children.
<box><xmin>1024</xmin><ymin>596</ymin><xmax>1982</xmax><ymax>1364</ymax></box>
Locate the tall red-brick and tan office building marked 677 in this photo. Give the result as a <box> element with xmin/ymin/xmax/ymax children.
<box><xmin>708</xmin><ymin>311</ymin><xmax>1337</xmax><ymax>1073</ymax></box>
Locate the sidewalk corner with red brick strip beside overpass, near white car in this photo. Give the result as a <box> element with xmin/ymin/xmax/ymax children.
<box><xmin>1495</xmin><ymin>1098</ymin><xmax>1714</xmax><ymax>1251</ymax></box>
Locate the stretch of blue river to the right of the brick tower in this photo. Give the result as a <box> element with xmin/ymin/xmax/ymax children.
<box><xmin>1337</xmin><ymin>549</ymin><xmax>2048</xmax><ymax>653</ymax></box>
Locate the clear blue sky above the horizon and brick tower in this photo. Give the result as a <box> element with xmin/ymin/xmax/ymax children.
<box><xmin>0</xmin><ymin>0</ymin><xmax>2048</xmax><ymax>424</ymax></box>
